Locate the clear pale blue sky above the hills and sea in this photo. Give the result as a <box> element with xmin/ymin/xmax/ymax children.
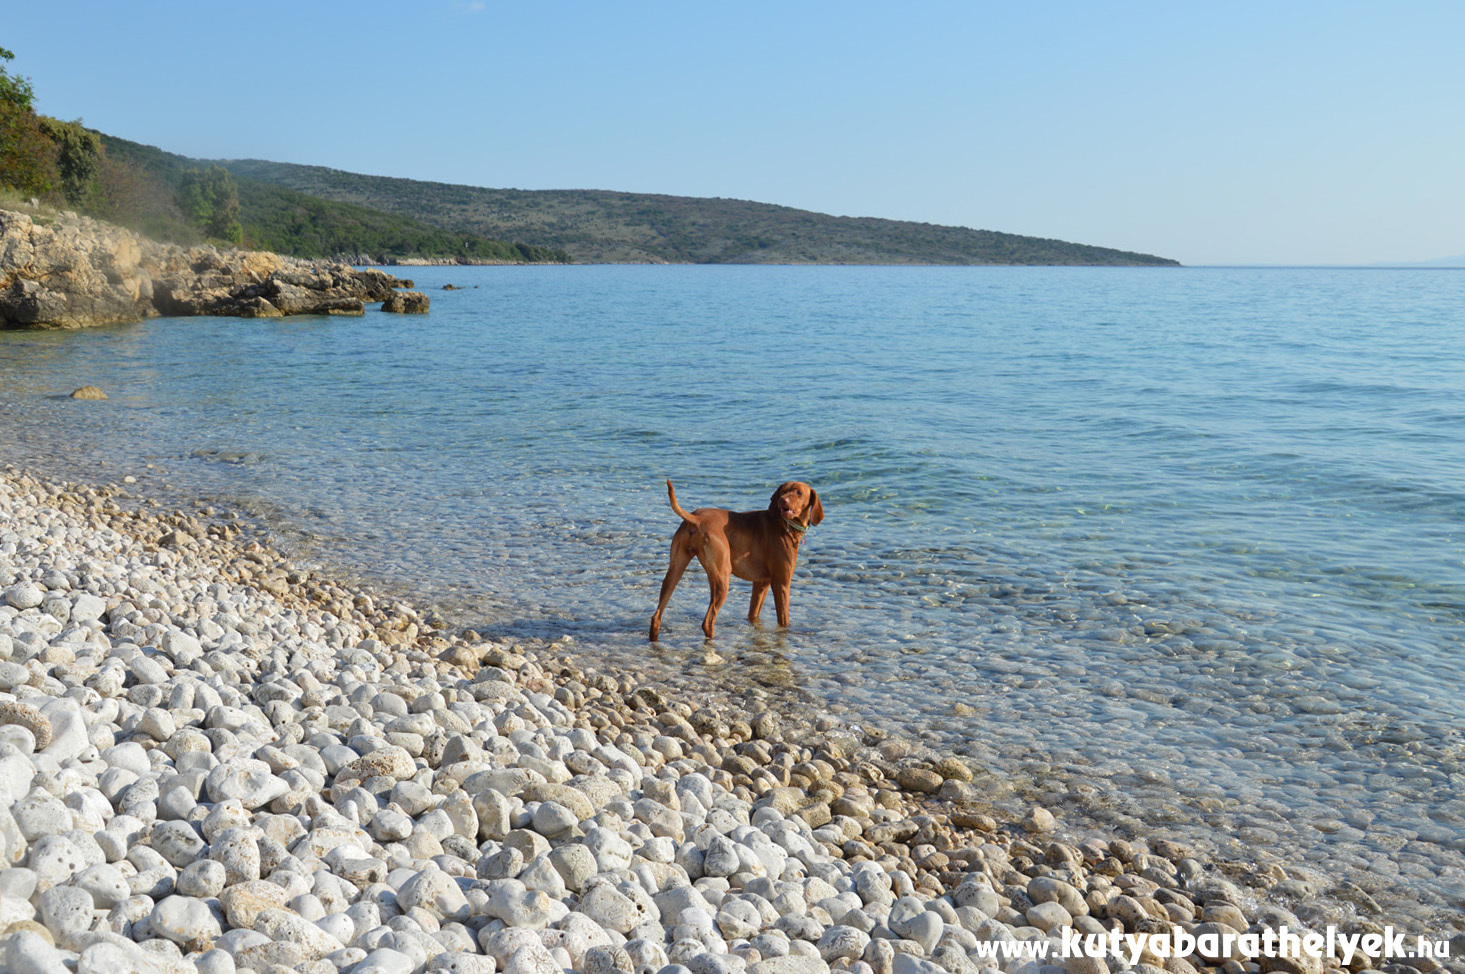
<box><xmin>0</xmin><ymin>0</ymin><xmax>1465</xmax><ymax>264</ymax></box>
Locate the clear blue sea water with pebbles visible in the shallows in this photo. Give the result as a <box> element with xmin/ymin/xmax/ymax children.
<box><xmin>0</xmin><ymin>267</ymin><xmax>1465</xmax><ymax>932</ymax></box>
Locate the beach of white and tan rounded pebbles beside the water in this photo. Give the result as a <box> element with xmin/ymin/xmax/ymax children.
<box><xmin>0</xmin><ymin>469</ymin><xmax>1465</xmax><ymax>974</ymax></box>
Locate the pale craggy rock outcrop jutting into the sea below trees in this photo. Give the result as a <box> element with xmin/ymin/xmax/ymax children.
<box><xmin>0</xmin><ymin>209</ymin><xmax>412</xmax><ymax>328</ymax></box>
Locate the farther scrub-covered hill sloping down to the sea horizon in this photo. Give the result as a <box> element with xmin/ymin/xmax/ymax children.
<box><xmin>218</xmin><ymin>160</ymin><xmax>1178</xmax><ymax>267</ymax></box>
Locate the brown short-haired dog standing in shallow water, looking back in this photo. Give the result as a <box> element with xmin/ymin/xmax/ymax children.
<box><xmin>650</xmin><ymin>480</ymin><xmax>823</xmax><ymax>642</ymax></box>
